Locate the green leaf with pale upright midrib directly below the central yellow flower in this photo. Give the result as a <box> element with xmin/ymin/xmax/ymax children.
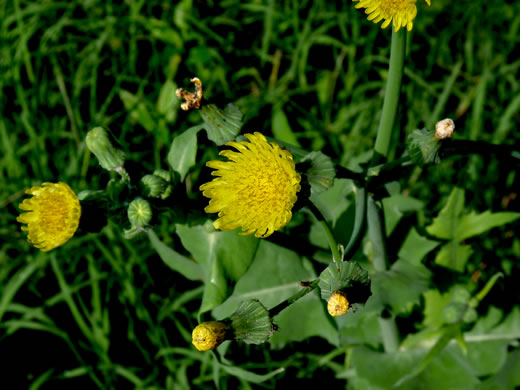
<box><xmin>177</xmin><ymin>222</ymin><xmax>259</xmax><ymax>313</ymax></box>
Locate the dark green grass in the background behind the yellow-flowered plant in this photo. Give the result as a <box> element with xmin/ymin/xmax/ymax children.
<box><xmin>0</xmin><ymin>0</ymin><xmax>520</xmax><ymax>390</ymax></box>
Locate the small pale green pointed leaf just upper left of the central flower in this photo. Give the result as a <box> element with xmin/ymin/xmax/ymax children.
<box><xmin>168</xmin><ymin>126</ymin><xmax>202</xmax><ymax>180</ymax></box>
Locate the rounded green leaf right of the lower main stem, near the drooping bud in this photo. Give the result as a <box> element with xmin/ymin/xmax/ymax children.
<box><xmin>372</xmin><ymin>259</ymin><xmax>431</xmax><ymax>314</ymax></box>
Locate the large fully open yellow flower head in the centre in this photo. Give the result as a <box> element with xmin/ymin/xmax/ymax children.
<box><xmin>200</xmin><ymin>133</ymin><xmax>301</xmax><ymax>237</ymax></box>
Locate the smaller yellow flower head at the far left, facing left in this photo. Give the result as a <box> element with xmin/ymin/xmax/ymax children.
<box><xmin>16</xmin><ymin>183</ymin><xmax>81</xmax><ymax>252</ymax></box>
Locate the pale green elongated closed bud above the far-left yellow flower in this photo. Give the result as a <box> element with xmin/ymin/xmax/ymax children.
<box><xmin>86</xmin><ymin>127</ymin><xmax>125</xmax><ymax>171</ymax></box>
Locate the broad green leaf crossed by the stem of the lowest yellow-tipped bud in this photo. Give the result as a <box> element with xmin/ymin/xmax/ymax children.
<box><xmin>213</xmin><ymin>240</ymin><xmax>337</xmax><ymax>348</ymax></box>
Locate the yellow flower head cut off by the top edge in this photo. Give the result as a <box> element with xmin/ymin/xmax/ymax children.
<box><xmin>352</xmin><ymin>0</ymin><xmax>431</xmax><ymax>31</ymax></box>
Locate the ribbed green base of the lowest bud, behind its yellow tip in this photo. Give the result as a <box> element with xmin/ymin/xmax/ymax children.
<box><xmin>229</xmin><ymin>299</ymin><xmax>274</xmax><ymax>344</ymax></box>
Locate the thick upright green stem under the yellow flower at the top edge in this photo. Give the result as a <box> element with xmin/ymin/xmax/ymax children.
<box><xmin>372</xmin><ymin>28</ymin><xmax>406</xmax><ymax>165</ymax></box>
